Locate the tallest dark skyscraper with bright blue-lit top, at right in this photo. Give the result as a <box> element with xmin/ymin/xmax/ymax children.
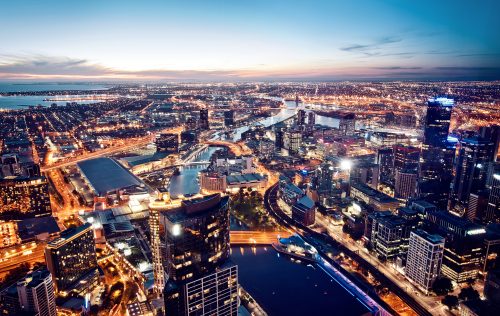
<box><xmin>418</xmin><ymin>98</ymin><xmax>455</xmax><ymax>209</ymax></box>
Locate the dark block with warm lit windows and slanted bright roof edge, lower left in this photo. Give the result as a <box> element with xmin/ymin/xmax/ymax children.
<box><xmin>45</xmin><ymin>223</ymin><xmax>99</xmax><ymax>295</ymax></box>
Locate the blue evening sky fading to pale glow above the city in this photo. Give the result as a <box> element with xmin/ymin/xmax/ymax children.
<box><xmin>0</xmin><ymin>0</ymin><xmax>500</xmax><ymax>81</ymax></box>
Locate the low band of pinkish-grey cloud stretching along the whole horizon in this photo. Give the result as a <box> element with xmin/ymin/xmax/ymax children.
<box><xmin>0</xmin><ymin>53</ymin><xmax>500</xmax><ymax>81</ymax></box>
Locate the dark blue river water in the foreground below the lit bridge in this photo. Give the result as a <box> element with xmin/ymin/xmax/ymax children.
<box><xmin>231</xmin><ymin>247</ymin><xmax>368</xmax><ymax>316</ymax></box>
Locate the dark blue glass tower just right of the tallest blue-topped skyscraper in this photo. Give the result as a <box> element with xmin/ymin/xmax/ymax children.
<box><xmin>450</xmin><ymin>137</ymin><xmax>494</xmax><ymax>209</ymax></box>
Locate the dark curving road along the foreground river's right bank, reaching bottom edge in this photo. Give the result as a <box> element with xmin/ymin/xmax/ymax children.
<box><xmin>264</xmin><ymin>185</ymin><xmax>433</xmax><ymax>316</ymax></box>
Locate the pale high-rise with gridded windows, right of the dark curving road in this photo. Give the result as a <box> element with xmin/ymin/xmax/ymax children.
<box><xmin>405</xmin><ymin>229</ymin><xmax>445</xmax><ymax>293</ymax></box>
